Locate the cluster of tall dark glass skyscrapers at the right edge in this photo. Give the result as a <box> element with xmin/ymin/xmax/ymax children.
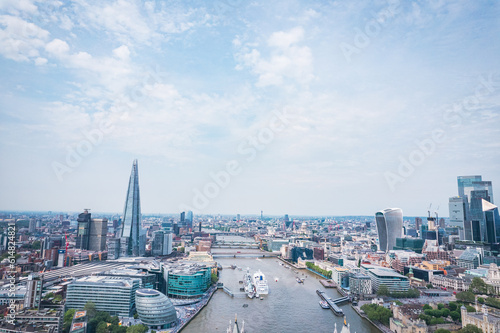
<box><xmin>449</xmin><ymin>176</ymin><xmax>500</xmax><ymax>243</ymax></box>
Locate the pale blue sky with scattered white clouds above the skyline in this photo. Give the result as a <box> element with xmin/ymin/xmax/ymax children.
<box><xmin>0</xmin><ymin>0</ymin><xmax>500</xmax><ymax>216</ymax></box>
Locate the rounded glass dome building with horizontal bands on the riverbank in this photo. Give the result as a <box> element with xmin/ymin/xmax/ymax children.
<box><xmin>135</xmin><ymin>289</ymin><xmax>177</xmax><ymax>329</ymax></box>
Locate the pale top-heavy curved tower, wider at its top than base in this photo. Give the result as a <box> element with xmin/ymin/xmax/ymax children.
<box><xmin>375</xmin><ymin>208</ymin><xmax>403</xmax><ymax>252</ymax></box>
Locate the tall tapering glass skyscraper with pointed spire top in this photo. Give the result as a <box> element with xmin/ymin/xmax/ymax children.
<box><xmin>120</xmin><ymin>160</ymin><xmax>146</xmax><ymax>257</ymax></box>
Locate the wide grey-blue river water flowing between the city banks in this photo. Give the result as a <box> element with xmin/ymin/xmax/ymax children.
<box><xmin>182</xmin><ymin>235</ymin><xmax>379</xmax><ymax>333</ymax></box>
